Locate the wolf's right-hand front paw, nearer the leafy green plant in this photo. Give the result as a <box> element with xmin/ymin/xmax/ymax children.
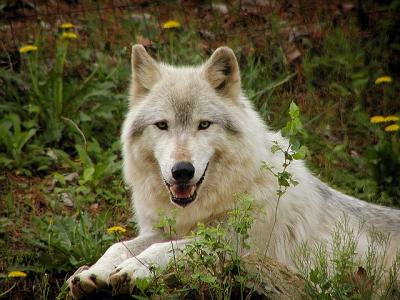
<box><xmin>109</xmin><ymin>257</ymin><xmax>151</xmax><ymax>295</ymax></box>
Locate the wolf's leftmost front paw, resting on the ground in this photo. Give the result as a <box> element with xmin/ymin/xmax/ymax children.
<box><xmin>67</xmin><ymin>266</ymin><xmax>109</xmax><ymax>299</ymax></box>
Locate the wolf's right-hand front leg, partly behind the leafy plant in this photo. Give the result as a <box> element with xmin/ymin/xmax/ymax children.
<box><xmin>110</xmin><ymin>240</ymin><xmax>188</xmax><ymax>295</ymax></box>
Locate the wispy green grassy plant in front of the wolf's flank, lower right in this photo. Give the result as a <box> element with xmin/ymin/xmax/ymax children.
<box><xmin>293</xmin><ymin>215</ymin><xmax>400</xmax><ymax>299</ymax></box>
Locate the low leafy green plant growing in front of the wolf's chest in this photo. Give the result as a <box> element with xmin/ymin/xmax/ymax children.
<box><xmin>133</xmin><ymin>194</ymin><xmax>255</xmax><ymax>299</ymax></box>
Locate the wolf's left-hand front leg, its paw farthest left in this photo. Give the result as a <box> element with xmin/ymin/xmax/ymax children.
<box><xmin>67</xmin><ymin>233</ymin><xmax>162</xmax><ymax>299</ymax></box>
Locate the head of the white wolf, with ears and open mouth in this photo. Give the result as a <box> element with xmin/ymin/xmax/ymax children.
<box><xmin>122</xmin><ymin>45</ymin><xmax>256</xmax><ymax>207</ymax></box>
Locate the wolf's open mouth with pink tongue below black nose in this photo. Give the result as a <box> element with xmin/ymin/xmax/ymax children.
<box><xmin>164</xmin><ymin>164</ymin><xmax>208</xmax><ymax>207</ymax></box>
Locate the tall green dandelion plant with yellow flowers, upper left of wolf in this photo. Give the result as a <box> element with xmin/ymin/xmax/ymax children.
<box><xmin>14</xmin><ymin>29</ymin><xmax>127</xmax><ymax>145</ymax></box>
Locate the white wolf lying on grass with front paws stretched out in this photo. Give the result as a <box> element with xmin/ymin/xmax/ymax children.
<box><xmin>68</xmin><ymin>45</ymin><xmax>400</xmax><ymax>298</ymax></box>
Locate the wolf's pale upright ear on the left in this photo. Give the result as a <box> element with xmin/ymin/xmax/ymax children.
<box><xmin>130</xmin><ymin>44</ymin><xmax>161</xmax><ymax>104</ymax></box>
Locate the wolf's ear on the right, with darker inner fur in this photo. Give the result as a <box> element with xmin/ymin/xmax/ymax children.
<box><xmin>204</xmin><ymin>47</ymin><xmax>240</xmax><ymax>101</ymax></box>
